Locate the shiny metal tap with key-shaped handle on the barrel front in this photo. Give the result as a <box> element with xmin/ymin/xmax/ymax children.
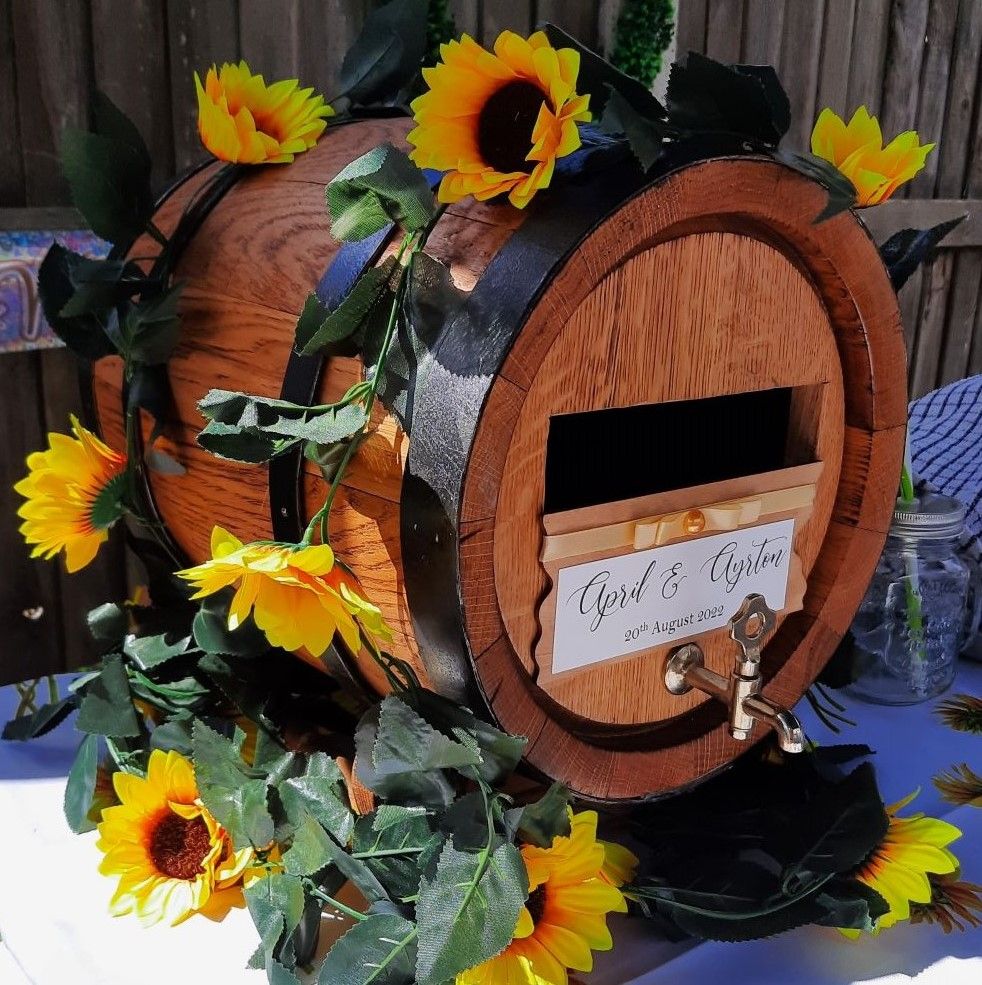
<box><xmin>665</xmin><ymin>594</ymin><xmax>805</xmax><ymax>752</ymax></box>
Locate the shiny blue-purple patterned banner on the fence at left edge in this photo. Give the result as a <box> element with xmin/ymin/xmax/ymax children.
<box><xmin>0</xmin><ymin>229</ymin><xmax>109</xmax><ymax>354</ymax></box>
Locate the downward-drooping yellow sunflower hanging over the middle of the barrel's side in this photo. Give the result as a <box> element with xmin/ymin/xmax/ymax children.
<box><xmin>177</xmin><ymin>527</ymin><xmax>392</xmax><ymax>657</ymax></box>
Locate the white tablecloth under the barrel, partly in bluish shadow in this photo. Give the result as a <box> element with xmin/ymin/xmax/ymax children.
<box><xmin>0</xmin><ymin>664</ymin><xmax>982</xmax><ymax>985</ymax></box>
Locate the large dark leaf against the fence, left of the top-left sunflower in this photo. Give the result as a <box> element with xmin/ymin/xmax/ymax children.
<box><xmin>61</xmin><ymin>129</ymin><xmax>154</xmax><ymax>251</ymax></box>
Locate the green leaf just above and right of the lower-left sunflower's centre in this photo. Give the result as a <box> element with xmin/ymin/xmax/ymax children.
<box><xmin>193</xmin><ymin>721</ymin><xmax>274</xmax><ymax>844</ymax></box>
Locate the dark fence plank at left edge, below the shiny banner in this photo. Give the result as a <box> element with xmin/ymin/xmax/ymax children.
<box><xmin>0</xmin><ymin>352</ymin><xmax>64</xmax><ymax>684</ymax></box>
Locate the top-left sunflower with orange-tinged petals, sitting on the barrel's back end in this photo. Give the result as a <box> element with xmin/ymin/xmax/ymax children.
<box><xmin>194</xmin><ymin>61</ymin><xmax>334</xmax><ymax>164</ymax></box>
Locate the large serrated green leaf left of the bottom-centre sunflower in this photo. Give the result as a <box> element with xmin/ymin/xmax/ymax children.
<box><xmin>416</xmin><ymin>842</ymin><xmax>528</xmax><ymax>985</ymax></box>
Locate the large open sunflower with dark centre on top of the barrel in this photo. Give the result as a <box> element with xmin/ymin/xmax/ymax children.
<box><xmin>407</xmin><ymin>31</ymin><xmax>590</xmax><ymax>209</ymax></box>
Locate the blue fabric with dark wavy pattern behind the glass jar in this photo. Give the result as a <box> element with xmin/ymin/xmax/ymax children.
<box><xmin>909</xmin><ymin>376</ymin><xmax>982</xmax><ymax>549</ymax></box>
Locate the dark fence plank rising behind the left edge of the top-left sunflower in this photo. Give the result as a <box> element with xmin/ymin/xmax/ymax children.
<box><xmin>167</xmin><ymin>0</ymin><xmax>239</xmax><ymax>172</ymax></box>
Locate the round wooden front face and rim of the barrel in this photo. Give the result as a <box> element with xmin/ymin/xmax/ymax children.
<box><xmin>460</xmin><ymin>161</ymin><xmax>905</xmax><ymax>799</ymax></box>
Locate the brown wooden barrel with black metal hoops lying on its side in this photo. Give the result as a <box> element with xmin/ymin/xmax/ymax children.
<box><xmin>95</xmin><ymin>120</ymin><xmax>906</xmax><ymax>801</ymax></box>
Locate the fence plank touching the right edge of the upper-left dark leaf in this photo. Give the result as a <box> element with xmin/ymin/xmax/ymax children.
<box><xmin>92</xmin><ymin>0</ymin><xmax>174</xmax><ymax>187</ymax></box>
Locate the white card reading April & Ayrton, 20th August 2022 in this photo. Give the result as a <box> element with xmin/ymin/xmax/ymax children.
<box><xmin>552</xmin><ymin>519</ymin><xmax>794</xmax><ymax>674</ymax></box>
